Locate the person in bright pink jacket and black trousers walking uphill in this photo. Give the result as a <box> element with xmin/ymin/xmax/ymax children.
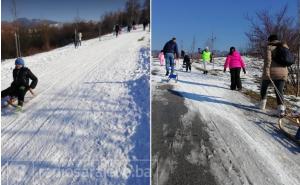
<box><xmin>224</xmin><ymin>47</ymin><xmax>246</xmax><ymax>91</ymax></box>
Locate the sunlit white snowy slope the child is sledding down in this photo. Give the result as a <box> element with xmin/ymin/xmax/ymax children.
<box><xmin>1</xmin><ymin>29</ymin><xmax>149</xmax><ymax>185</ymax></box>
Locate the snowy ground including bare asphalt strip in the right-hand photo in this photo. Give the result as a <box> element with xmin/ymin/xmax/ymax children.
<box><xmin>151</xmin><ymin>58</ymin><xmax>300</xmax><ymax>185</ymax></box>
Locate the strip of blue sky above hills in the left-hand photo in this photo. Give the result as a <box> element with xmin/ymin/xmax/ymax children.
<box><xmin>1</xmin><ymin>0</ymin><xmax>126</xmax><ymax>22</ymax></box>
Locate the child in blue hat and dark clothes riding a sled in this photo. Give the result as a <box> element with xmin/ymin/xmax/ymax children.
<box><xmin>1</xmin><ymin>58</ymin><xmax>38</xmax><ymax>109</ymax></box>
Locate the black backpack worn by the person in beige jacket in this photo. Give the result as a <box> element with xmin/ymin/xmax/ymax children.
<box><xmin>272</xmin><ymin>44</ymin><xmax>295</xmax><ymax>67</ymax></box>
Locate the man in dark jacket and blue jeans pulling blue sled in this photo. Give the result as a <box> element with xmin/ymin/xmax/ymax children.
<box><xmin>163</xmin><ymin>37</ymin><xmax>179</xmax><ymax>76</ymax></box>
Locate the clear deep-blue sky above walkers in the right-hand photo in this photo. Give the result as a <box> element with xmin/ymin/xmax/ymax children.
<box><xmin>151</xmin><ymin>0</ymin><xmax>297</xmax><ymax>50</ymax></box>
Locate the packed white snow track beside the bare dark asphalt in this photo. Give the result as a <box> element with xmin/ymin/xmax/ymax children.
<box><xmin>152</xmin><ymin>60</ymin><xmax>300</xmax><ymax>185</ymax></box>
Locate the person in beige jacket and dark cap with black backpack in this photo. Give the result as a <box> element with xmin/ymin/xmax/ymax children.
<box><xmin>258</xmin><ymin>34</ymin><xmax>288</xmax><ymax>116</ymax></box>
